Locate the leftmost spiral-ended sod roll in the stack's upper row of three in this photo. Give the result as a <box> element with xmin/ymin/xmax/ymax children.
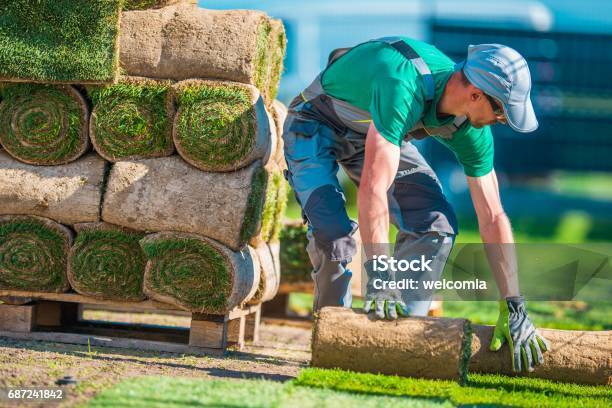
<box><xmin>0</xmin><ymin>84</ymin><xmax>89</xmax><ymax>165</ymax></box>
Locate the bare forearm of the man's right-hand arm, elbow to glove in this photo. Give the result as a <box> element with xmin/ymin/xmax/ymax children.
<box><xmin>479</xmin><ymin>213</ymin><xmax>520</xmax><ymax>298</ymax></box>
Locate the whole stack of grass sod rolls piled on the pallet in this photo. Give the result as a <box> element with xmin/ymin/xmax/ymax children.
<box><xmin>0</xmin><ymin>0</ymin><xmax>287</xmax><ymax>313</ymax></box>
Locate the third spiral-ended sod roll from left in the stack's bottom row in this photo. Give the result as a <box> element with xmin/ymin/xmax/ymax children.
<box><xmin>140</xmin><ymin>232</ymin><xmax>259</xmax><ymax>314</ymax></box>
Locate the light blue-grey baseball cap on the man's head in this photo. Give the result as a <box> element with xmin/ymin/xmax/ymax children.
<box><xmin>457</xmin><ymin>44</ymin><xmax>538</xmax><ymax>133</ymax></box>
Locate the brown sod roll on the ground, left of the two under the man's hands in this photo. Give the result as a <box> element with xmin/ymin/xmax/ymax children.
<box><xmin>312</xmin><ymin>307</ymin><xmax>471</xmax><ymax>383</ymax></box>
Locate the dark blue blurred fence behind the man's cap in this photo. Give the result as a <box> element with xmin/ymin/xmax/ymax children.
<box><xmin>427</xmin><ymin>22</ymin><xmax>612</xmax><ymax>175</ymax></box>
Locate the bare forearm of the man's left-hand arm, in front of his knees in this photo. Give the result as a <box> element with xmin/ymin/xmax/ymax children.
<box><xmin>357</xmin><ymin>185</ymin><xmax>389</xmax><ymax>259</ymax></box>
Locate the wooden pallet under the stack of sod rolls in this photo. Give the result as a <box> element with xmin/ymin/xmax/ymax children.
<box><xmin>0</xmin><ymin>290</ymin><xmax>261</xmax><ymax>355</ymax></box>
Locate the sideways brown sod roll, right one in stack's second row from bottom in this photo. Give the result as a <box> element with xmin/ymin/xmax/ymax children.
<box><xmin>102</xmin><ymin>156</ymin><xmax>268</xmax><ymax>250</ymax></box>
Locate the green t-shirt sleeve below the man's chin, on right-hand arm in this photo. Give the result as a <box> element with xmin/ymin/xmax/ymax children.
<box><xmin>436</xmin><ymin>123</ymin><xmax>495</xmax><ymax>177</ymax></box>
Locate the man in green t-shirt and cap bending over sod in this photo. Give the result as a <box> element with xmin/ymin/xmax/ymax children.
<box><xmin>283</xmin><ymin>37</ymin><xmax>547</xmax><ymax>371</ymax></box>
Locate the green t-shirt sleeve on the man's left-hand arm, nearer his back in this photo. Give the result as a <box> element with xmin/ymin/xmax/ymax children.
<box><xmin>370</xmin><ymin>78</ymin><xmax>423</xmax><ymax>146</ymax></box>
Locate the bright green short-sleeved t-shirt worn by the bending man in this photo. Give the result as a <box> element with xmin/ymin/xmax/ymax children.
<box><xmin>321</xmin><ymin>37</ymin><xmax>493</xmax><ymax>177</ymax></box>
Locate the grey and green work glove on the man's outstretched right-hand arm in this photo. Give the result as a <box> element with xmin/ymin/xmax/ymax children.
<box><xmin>489</xmin><ymin>296</ymin><xmax>550</xmax><ymax>372</ymax></box>
